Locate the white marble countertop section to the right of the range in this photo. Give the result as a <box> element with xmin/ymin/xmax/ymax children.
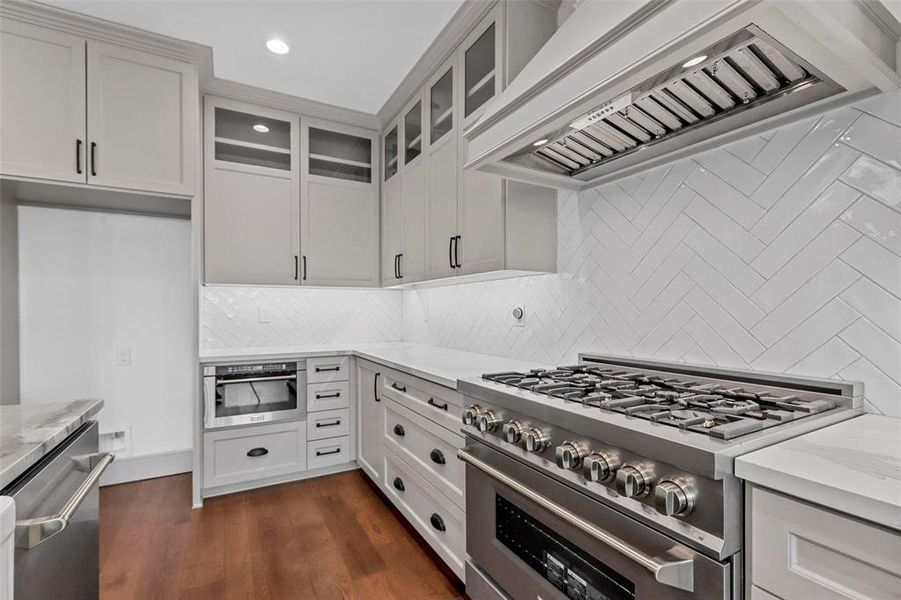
<box><xmin>735</xmin><ymin>415</ymin><xmax>901</xmax><ymax>530</ymax></box>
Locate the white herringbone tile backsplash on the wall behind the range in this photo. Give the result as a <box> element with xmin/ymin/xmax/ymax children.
<box><xmin>403</xmin><ymin>93</ymin><xmax>901</xmax><ymax>416</ymax></box>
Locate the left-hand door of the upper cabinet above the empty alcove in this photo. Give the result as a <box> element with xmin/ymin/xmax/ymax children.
<box><xmin>0</xmin><ymin>19</ymin><xmax>87</xmax><ymax>183</ymax></box>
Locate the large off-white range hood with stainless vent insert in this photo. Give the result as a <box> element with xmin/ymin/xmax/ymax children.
<box><xmin>464</xmin><ymin>0</ymin><xmax>901</xmax><ymax>189</ymax></box>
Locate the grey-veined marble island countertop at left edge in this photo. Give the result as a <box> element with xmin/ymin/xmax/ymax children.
<box><xmin>0</xmin><ymin>399</ymin><xmax>103</xmax><ymax>489</ymax></box>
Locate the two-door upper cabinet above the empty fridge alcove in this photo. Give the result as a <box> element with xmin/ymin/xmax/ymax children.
<box><xmin>0</xmin><ymin>19</ymin><xmax>198</xmax><ymax>196</ymax></box>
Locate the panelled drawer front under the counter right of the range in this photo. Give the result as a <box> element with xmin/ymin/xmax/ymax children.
<box><xmin>751</xmin><ymin>487</ymin><xmax>901</xmax><ymax>600</ymax></box>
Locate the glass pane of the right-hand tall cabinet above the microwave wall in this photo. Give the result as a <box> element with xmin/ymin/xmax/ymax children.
<box><xmin>309</xmin><ymin>127</ymin><xmax>372</xmax><ymax>183</ymax></box>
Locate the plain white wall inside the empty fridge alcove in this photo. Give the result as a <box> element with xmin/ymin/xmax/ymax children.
<box><xmin>19</xmin><ymin>206</ymin><xmax>197</xmax><ymax>456</ymax></box>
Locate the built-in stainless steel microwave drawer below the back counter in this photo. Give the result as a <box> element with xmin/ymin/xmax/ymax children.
<box><xmin>203</xmin><ymin>360</ymin><xmax>307</xmax><ymax>429</ymax></box>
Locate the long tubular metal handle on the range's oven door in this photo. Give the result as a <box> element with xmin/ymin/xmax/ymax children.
<box><xmin>457</xmin><ymin>450</ymin><xmax>694</xmax><ymax>592</ymax></box>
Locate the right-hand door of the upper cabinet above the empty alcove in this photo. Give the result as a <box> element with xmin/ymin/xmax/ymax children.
<box><xmin>87</xmin><ymin>40</ymin><xmax>197</xmax><ymax>196</ymax></box>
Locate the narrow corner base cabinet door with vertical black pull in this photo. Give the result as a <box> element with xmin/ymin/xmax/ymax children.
<box><xmin>355</xmin><ymin>359</ymin><xmax>385</xmax><ymax>484</ymax></box>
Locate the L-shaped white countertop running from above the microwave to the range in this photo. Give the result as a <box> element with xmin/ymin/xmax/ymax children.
<box><xmin>200</xmin><ymin>342</ymin><xmax>545</xmax><ymax>389</ymax></box>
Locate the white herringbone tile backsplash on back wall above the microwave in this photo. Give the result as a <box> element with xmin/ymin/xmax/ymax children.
<box><xmin>206</xmin><ymin>285</ymin><xmax>403</xmax><ymax>350</ymax></box>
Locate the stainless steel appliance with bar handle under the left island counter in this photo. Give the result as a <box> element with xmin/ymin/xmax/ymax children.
<box><xmin>2</xmin><ymin>422</ymin><xmax>113</xmax><ymax>600</ymax></box>
